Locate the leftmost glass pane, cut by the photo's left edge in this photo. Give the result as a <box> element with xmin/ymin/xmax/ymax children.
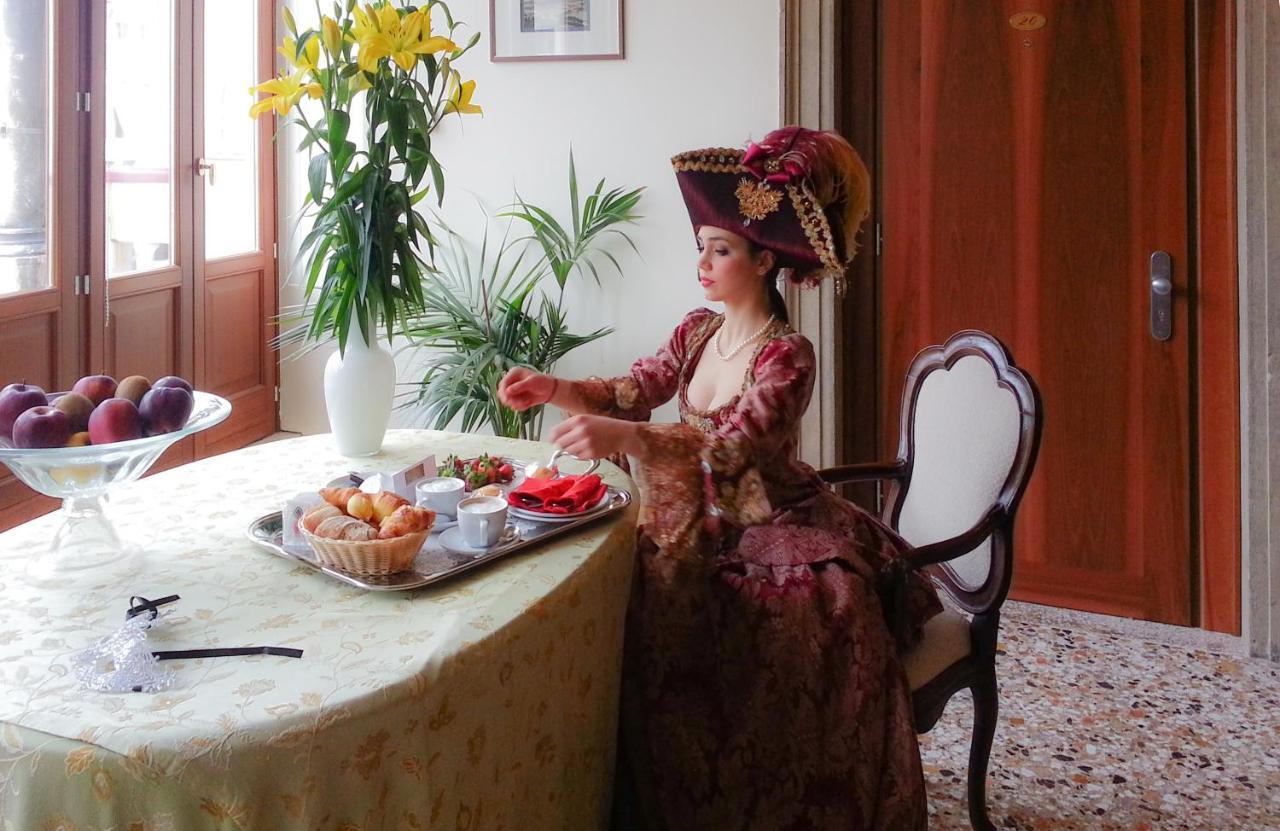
<box><xmin>0</xmin><ymin>0</ymin><xmax>52</xmax><ymax>296</ymax></box>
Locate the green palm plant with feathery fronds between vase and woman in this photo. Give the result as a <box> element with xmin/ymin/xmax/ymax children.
<box><xmin>403</xmin><ymin>154</ymin><xmax>644</xmax><ymax>439</ymax></box>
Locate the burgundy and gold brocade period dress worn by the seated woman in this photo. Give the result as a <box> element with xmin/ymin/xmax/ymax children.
<box><xmin>579</xmin><ymin>309</ymin><xmax>940</xmax><ymax>831</ymax></box>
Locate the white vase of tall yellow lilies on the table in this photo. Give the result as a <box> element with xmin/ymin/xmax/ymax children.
<box><xmin>250</xmin><ymin>0</ymin><xmax>480</xmax><ymax>456</ymax></box>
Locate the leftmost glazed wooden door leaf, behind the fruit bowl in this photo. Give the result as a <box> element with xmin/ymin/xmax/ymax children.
<box><xmin>0</xmin><ymin>0</ymin><xmax>87</xmax><ymax>528</ymax></box>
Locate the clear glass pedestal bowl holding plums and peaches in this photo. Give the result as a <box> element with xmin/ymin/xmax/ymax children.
<box><xmin>0</xmin><ymin>392</ymin><xmax>232</xmax><ymax>585</ymax></box>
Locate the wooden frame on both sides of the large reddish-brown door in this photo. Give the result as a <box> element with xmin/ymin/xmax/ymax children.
<box><xmin>798</xmin><ymin>0</ymin><xmax>1239</xmax><ymax>632</ymax></box>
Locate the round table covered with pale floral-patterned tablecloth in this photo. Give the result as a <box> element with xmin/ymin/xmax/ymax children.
<box><xmin>0</xmin><ymin>430</ymin><xmax>636</xmax><ymax>831</ymax></box>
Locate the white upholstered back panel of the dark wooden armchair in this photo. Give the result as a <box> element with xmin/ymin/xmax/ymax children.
<box><xmin>897</xmin><ymin>355</ymin><xmax>1021</xmax><ymax>590</ymax></box>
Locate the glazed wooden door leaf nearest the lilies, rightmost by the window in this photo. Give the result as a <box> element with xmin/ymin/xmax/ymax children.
<box><xmin>192</xmin><ymin>0</ymin><xmax>278</xmax><ymax>457</ymax></box>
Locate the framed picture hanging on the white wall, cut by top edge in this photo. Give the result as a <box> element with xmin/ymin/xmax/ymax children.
<box><xmin>489</xmin><ymin>0</ymin><xmax>622</xmax><ymax>60</ymax></box>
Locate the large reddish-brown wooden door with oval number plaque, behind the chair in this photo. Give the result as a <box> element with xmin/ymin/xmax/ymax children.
<box><xmin>878</xmin><ymin>0</ymin><xmax>1193</xmax><ymax>624</ymax></box>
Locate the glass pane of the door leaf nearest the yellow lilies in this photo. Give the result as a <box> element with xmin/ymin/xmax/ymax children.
<box><xmin>205</xmin><ymin>0</ymin><xmax>259</xmax><ymax>260</ymax></box>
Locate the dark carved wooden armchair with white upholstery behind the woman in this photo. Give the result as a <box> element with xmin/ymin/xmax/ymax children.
<box><xmin>820</xmin><ymin>330</ymin><xmax>1042</xmax><ymax>831</ymax></box>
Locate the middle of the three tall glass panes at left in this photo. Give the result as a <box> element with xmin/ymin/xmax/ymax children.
<box><xmin>105</xmin><ymin>0</ymin><xmax>174</xmax><ymax>277</ymax></box>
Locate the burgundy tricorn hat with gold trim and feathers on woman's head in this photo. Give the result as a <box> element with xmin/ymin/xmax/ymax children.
<box><xmin>671</xmin><ymin>127</ymin><xmax>870</xmax><ymax>291</ymax></box>
